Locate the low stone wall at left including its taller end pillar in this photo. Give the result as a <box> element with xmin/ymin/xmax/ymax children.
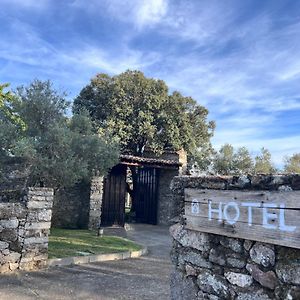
<box><xmin>0</xmin><ymin>188</ymin><xmax>53</xmax><ymax>273</ymax></box>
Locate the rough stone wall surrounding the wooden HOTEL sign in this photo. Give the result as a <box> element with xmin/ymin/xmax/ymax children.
<box><xmin>170</xmin><ymin>175</ymin><xmax>300</xmax><ymax>300</ymax></box>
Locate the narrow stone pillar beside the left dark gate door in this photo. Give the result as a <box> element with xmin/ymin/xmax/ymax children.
<box><xmin>88</xmin><ymin>176</ymin><xmax>104</xmax><ymax>230</ymax></box>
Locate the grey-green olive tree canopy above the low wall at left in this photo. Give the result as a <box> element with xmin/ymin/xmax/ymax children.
<box><xmin>0</xmin><ymin>80</ymin><xmax>119</xmax><ymax>188</ymax></box>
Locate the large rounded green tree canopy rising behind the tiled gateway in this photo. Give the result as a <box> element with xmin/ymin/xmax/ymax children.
<box><xmin>74</xmin><ymin>71</ymin><xmax>215</xmax><ymax>162</ymax></box>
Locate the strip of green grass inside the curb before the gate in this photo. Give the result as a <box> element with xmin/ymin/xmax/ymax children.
<box><xmin>49</xmin><ymin>228</ymin><xmax>141</xmax><ymax>258</ymax></box>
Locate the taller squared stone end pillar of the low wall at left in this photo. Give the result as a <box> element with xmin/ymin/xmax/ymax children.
<box><xmin>19</xmin><ymin>188</ymin><xmax>54</xmax><ymax>270</ymax></box>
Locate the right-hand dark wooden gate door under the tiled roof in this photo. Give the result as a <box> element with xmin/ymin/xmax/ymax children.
<box><xmin>134</xmin><ymin>167</ymin><xmax>159</xmax><ymax>225</ymax></box>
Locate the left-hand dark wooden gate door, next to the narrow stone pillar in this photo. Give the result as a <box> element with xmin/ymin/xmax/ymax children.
<box><xmin>101</xmin><ymin>165</ymin><xmax>126</xmax><ymax>226</ymax></box>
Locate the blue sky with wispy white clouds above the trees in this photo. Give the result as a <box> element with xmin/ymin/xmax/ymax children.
<box><xmin>0</xmin><ymin>0</ymin><xmax>300</xmax><ymax>166</ymax></box>
